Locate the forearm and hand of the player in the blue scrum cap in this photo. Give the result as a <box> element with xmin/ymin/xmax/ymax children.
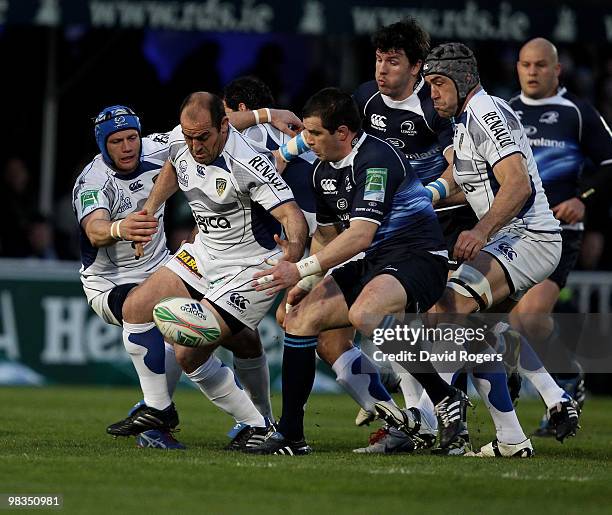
<box><xmin>81</xmin><ymin>209</ymin><xmax>159</xmax><ymax>248</ymax></box>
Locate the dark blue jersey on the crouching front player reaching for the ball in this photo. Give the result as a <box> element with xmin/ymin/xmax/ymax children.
<box><xmin>313</xmin><ymin>133</ymin><xmax>446</xmax><ymax>255</ymax></box>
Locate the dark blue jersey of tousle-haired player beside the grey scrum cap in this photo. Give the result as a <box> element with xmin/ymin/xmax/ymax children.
<box><xmin>353</xmin><ymin>78</ymin><xmax>453</xmax><ymax>184</ymax></box>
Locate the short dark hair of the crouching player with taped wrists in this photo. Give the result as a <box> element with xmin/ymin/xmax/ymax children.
<box><xmin>303</xmin><ymin>88</ymin><xmax>361</xmax><ymax>134</ymax></box>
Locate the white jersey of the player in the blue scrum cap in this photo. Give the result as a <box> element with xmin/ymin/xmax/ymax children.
<box><xmin>72</xmin><ymin>133</ymin><xmax>169</xmax><ymax>294</ymax></box>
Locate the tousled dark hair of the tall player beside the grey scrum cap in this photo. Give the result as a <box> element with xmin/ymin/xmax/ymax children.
<box><xmin>372</xmin><ymin>18</ymin><xmax>429</xmax><ymax>64</ymax></box>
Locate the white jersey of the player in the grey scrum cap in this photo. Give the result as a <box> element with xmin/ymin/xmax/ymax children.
<box><xmin>453</xmin><ymin>90</ymin><xmax>560</xmax><ymax>232</ymax></box>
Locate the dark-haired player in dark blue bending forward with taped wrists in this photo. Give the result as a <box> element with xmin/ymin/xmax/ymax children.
<box><xmin>249</xmin><ymin>88</ymin><xmax>463</xmax><ymax>455</ymax></box>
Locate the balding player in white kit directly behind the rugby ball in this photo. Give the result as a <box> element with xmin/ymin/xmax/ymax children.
<box><xmin>116</xmin><ymin>92</ymin><xmax>307</xmax><ymax>445</ymax></box>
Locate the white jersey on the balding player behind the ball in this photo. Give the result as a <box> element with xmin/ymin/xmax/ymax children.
<box><xmin>169</xmin><ymin>125</ymin><xmax>294</xmax><ymax>259</ymax></box>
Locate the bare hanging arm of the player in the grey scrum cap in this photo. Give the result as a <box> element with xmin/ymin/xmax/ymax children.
<box><xmin>454</xmin><ymin>153</ymin><xmax>531</xmax><ymax>260</ymax></box>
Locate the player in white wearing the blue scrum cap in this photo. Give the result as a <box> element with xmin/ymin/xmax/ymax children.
<box><xmin>73</xmin><ymin>105</ymin><xmax>278</xmax><ymax>448</ymax></box>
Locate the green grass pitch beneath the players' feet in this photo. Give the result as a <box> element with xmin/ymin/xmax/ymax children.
<box><xmin>0</xmin><ymin>387</ymin><xmax>612</xmax><ymax>515</ymax></box>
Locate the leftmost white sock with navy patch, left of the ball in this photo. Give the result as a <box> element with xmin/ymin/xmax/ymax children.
<box><xmin>123</xmin><ymin>322</ymin><xmax>172</xmax><ymax>410</ymax></box>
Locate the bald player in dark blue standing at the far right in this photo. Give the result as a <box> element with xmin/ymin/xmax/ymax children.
<box><xmin>509</xmin><ymin>38</ymin><xmax>612</xmax><ymax>436</ymax></box>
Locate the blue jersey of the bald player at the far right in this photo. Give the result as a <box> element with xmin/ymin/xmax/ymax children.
<box><xmin>509</xmin><ymin>87</ymin><xmax>612</xmax><ymax>211</ymax></box>
